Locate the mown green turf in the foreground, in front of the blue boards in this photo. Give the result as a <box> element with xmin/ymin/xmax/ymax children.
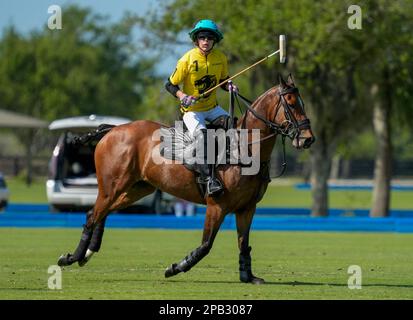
<box><xmin>0</xmin><ymin>228</ymin><xmax>413</xmax><ymax>299</ymax></box>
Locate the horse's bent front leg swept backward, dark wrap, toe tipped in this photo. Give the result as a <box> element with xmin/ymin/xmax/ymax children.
<box><xmin>165</xmin><ymin>205</ymin><xmax>225</xmax><ymax>278</ymax></box>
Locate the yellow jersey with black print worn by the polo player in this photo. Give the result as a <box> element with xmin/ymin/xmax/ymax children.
<box><xmin>169</xmin><ymin>48</ymin><xmax>228</xmax><ymax>111</ymax></box>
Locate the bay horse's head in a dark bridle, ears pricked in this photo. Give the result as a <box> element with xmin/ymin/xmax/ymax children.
<box><xmin>272</xmin><ymin>74</ymin><xmax>315</xmax><ymax>149</ymax></box>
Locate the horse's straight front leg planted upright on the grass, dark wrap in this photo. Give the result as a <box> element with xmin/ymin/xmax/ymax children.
<box><xmin>236</xmin><ymin>206</ymin><xmax>264</xmax><ymax>284</ymax></box>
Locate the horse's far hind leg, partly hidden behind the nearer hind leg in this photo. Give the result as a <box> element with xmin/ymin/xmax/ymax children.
<box><xmin>78</xmin><ymin>181</ymin><xmax>155</xmax><ymax>267</ymax></box>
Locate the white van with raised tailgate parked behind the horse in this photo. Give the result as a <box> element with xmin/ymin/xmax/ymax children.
<box><xmin>46</xmin><ymin>115</ymin><xmax>175</xmax><ymax>214</ymax></box>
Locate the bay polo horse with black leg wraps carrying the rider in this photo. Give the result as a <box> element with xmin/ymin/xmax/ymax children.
<box><xmin>58</xmin><ymin>75</ymin><xmax>315</xmax><ymax>284</ymax></box>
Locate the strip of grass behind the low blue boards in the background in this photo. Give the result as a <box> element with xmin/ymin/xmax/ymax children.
<box><xmin>7</xmin><ymin>179</ymin><xmax>413</xmax><ymax>210</ymax></box>
